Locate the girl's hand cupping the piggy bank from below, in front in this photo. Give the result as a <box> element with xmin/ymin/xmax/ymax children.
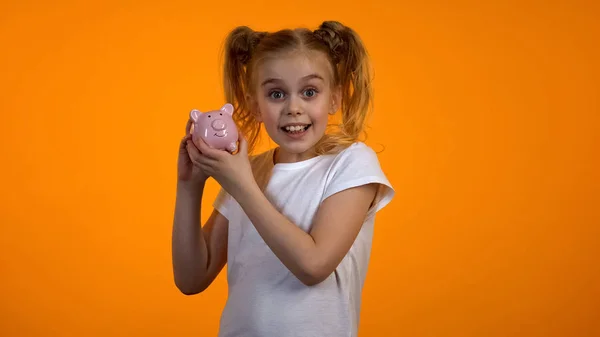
<box><xmin>197</xmin><ymin>133</ymin><xmax>256</xmax><ymax>198</ymax></box>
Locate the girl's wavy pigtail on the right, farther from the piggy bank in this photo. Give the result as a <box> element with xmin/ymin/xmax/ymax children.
<box><xmin>314</xmin><ymin>21</ymin><xmax>373</xmax><ymax>149</ymax></box>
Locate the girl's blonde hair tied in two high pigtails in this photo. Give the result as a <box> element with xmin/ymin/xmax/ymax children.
<box><xmin>223</xmin><ymin>21</ymin><xmax>373</xmax><ymax>155</ymax></box>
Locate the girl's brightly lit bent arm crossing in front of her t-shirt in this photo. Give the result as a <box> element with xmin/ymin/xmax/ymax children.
<box><xmin>236</xmin><ymin>180</ymin><xmax>377</xmax><ymax>286</ymax></box>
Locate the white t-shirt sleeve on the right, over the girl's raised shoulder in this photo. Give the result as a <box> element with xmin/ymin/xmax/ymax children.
<box><xmin>322</xmin><ymin>143</ymin><xmax>395</xmax><ymax>216</ymax></box>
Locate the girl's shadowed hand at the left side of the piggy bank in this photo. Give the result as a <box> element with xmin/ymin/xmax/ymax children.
<box><xmin>177</xmin><ymin>119</ymin><xmax>208</xmax><ymax>185</ymax></box>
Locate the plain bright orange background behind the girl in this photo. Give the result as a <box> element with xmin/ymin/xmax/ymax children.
<box><xmin>0</xmin><ymin>0</ymin><xmax>600</xmax><ymax>337</ymax></box>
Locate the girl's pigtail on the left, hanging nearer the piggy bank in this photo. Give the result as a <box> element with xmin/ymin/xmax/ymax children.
<box><xmin>223</xmin><ymin>26</ymin><xmax>265</xmax><ymax>153</ymax></box>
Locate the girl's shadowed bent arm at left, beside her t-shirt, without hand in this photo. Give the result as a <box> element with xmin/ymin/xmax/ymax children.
<box><xmin>172</xmin><ymin>183</ymin><xmax>228</xmax><ymax>295</ymax></box>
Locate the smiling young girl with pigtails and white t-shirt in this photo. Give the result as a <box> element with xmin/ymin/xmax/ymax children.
<box><xmin>172</xmin><ymin>22</ymin><xmax>394</xmax><ymax>337</ymax></box>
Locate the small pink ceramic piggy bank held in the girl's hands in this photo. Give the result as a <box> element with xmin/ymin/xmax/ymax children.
<box><xmin>190</xmin><ymin>103</ymin><xmax>238</xmax><ymax>153</ymax></box>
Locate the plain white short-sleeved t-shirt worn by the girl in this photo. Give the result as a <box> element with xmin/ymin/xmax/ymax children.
<box><xmin>214</xmin><ymin>142</ymin><xmax>394</xmax><ymax>337</ymax></box>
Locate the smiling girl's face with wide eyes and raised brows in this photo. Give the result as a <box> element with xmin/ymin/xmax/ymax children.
<box><xmin>252</xmin><ymin>52</ymin><xmax>340</xmax><ymax>162</ymax></box>
